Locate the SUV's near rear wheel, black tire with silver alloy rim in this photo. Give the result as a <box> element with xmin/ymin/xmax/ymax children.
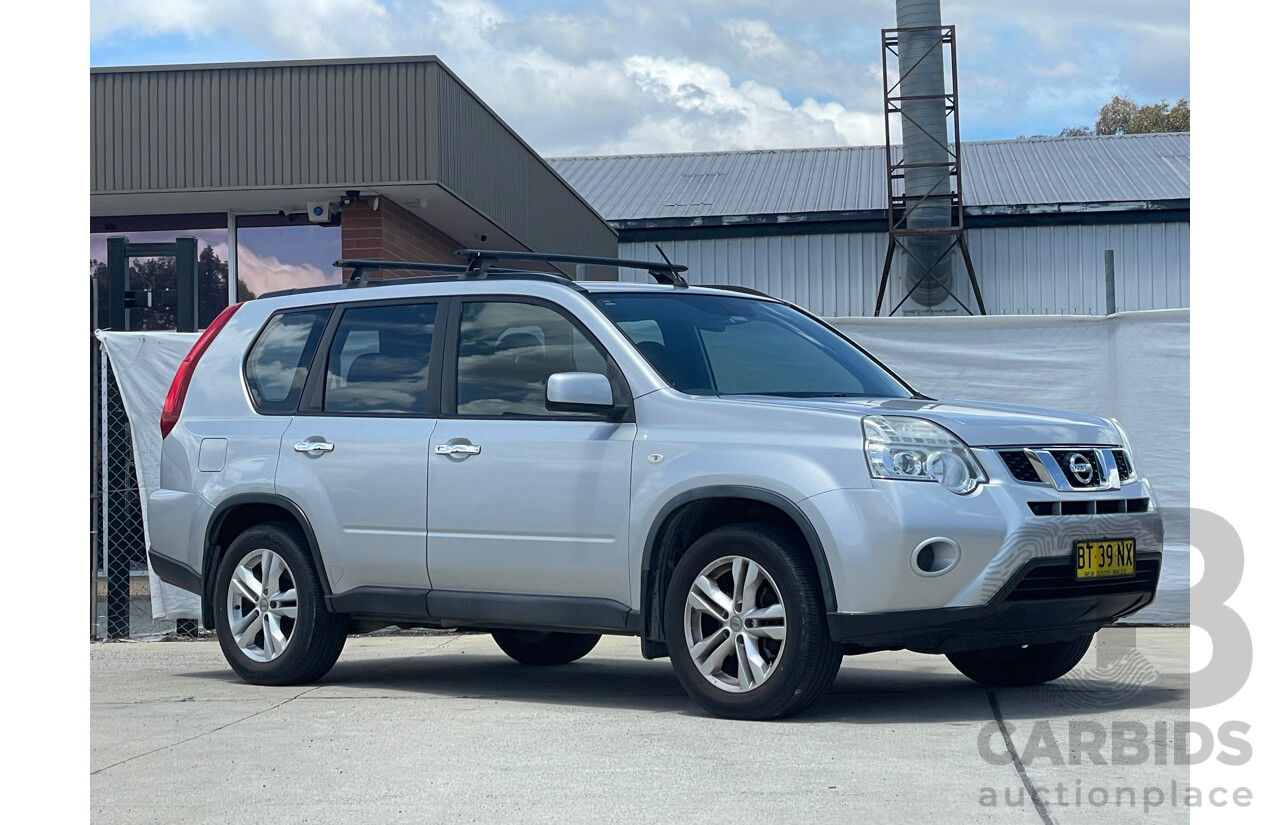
<box><xmin>211</xmin><ymin>522</ymin><xmax>348</xmax><ymax>684</ymax></box>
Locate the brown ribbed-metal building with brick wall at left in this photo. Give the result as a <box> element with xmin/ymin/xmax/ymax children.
<box><xmin>90</xmin><ymin>56</ymin><xmax>617</xmax><ymax>329</ymax></box>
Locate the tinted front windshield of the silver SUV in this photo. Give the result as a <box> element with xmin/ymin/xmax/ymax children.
<box><xmin>593</xmin><ymin>293</ymin><xmax>911</xmax><ymax>398</ymax></box>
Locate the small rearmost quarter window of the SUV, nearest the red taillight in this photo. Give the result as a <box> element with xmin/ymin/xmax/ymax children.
<box><xmin>244</xmin><ymin>307</ymin><xmax>332</xmax><ymax>413</ymax></box>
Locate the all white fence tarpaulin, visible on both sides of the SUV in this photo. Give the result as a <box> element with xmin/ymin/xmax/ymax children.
<box><xmin>97</xmin><ymin>310</ymin><xmax>1190</xmax><ymax>622</ymax></box>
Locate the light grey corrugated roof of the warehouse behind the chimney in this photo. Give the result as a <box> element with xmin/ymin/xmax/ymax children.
<box><xmin>549</xmin><ymin>132</ymin><xmax>1192</xmax><ymax>220</ymax></box>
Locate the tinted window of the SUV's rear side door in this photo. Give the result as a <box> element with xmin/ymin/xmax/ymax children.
<box><xmin>324</xmin><ymin>303</ymin><xmax>435</xmax><ymax>414</ymax></box>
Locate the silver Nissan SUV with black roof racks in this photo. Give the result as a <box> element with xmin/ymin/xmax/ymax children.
<box><xmin>148</xmin><ymin>251</ymin><xmax>1164</xmax><ymax>719</ymax></box>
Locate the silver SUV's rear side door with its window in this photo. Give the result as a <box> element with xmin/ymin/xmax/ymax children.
<box><xmin>276</xmin><ymin>299</ymin><xmax>443</xmax><ymax>593</ymax></box>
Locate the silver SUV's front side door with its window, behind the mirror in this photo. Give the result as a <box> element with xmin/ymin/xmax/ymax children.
<box><xmin>428</xmin><ymin>297</ymin><xmax>636</xmax><ymax>605</ymax></box>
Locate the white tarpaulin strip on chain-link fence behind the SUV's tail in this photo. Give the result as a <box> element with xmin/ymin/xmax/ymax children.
<box><xmin>97</xmin><ymin>330</ymin><xmax>200</xmax><ymax>622</ymax></box>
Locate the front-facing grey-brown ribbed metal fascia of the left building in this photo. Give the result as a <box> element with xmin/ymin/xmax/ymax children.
<box><xmin>90</xmin><ymin>63</ymin><xmax>442</xmax><ymax>193</ymax></box>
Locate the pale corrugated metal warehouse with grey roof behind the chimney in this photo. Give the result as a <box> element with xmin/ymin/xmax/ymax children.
<box><xmin>550</xmin><ymin>133</ymin><xmax>1190</xmax><ymax>317</ymax></box>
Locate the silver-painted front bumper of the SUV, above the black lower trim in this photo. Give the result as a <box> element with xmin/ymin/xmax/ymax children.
<box><xmin>800</xmin><ymin>450</ymin><xmax>1164</xmax><ymax>625</ymax></box>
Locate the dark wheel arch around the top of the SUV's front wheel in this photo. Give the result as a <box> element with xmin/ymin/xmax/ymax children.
<box><xmin>640</xmin><ymin>485</ymin><xmax>836</xmax><ymax>642</ymax></box>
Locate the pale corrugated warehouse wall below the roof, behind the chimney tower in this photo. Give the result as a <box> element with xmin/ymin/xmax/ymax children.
<box><xmin>618</xmin><ymin>223</ymin><xmax>1190</xmax><ymax>317</ymax></box>
